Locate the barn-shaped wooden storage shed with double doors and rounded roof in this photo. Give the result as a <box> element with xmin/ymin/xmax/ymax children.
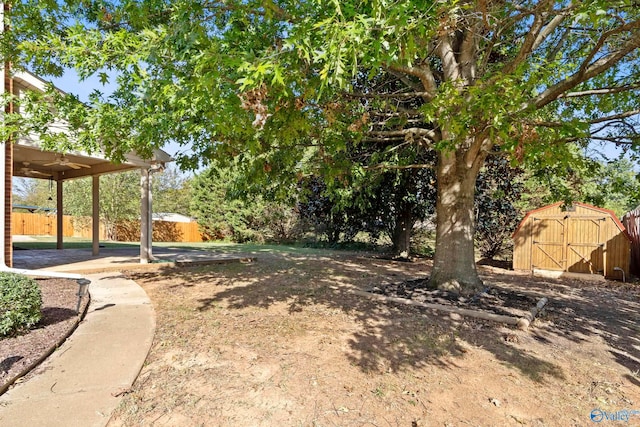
<box><xmin>513</xmin><ymin>203</ymin><xmax>631</xmax><ymax>280</ymax></box>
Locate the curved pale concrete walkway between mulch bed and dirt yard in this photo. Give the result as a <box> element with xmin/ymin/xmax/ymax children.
<box><xmin>0</xmin><ymin>272</ymin><xmax>155</xmax><ymax>427</ymax></box>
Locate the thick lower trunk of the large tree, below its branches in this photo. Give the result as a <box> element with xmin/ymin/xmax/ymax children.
<box><xmin>430</xmin><ymin>150</ymin><xmax>485</xmax><ymax>295</ymax></box>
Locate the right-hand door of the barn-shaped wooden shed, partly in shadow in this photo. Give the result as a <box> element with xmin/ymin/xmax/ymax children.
<box><xmin>566</xmin><ymin>217</ymin><xmax>606</xmax><ymax>274</ymax></box>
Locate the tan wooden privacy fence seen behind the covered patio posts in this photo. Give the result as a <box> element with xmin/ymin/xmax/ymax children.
<box><xmin>11</xmin><ymin>212</ymin><xmax>203</xmax><ymax>242</ymax></box>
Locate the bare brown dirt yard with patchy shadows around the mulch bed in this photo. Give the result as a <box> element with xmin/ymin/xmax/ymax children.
<box><xmin>99</xmin><ymin>255</ymin><xmax>640</xmax><ymax>427</ymax></box>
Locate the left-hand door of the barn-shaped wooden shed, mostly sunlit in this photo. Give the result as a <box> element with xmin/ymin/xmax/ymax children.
<box><xmin>531</xmin><ymin>218</ymin><xmax>565</xmax><ymax>271</ymax></box>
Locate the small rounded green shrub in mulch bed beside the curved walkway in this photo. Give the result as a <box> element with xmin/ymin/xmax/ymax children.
<box><xmin>0</xmin><ymin>273</ymin><xmax>42</xmax><ymax>336</ymax></box>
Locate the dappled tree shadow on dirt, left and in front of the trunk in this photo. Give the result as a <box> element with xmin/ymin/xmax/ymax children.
<box><xmin>134</xmin><ymin>254</ymin><xmax>576</xmax><ymax>382</ymax></box>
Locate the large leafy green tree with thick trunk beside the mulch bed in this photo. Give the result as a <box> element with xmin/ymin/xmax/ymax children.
<box><xmin>3</xmin><ymin>0</ymin><xmax>640</xmax><ymax>292</ymax></box>
